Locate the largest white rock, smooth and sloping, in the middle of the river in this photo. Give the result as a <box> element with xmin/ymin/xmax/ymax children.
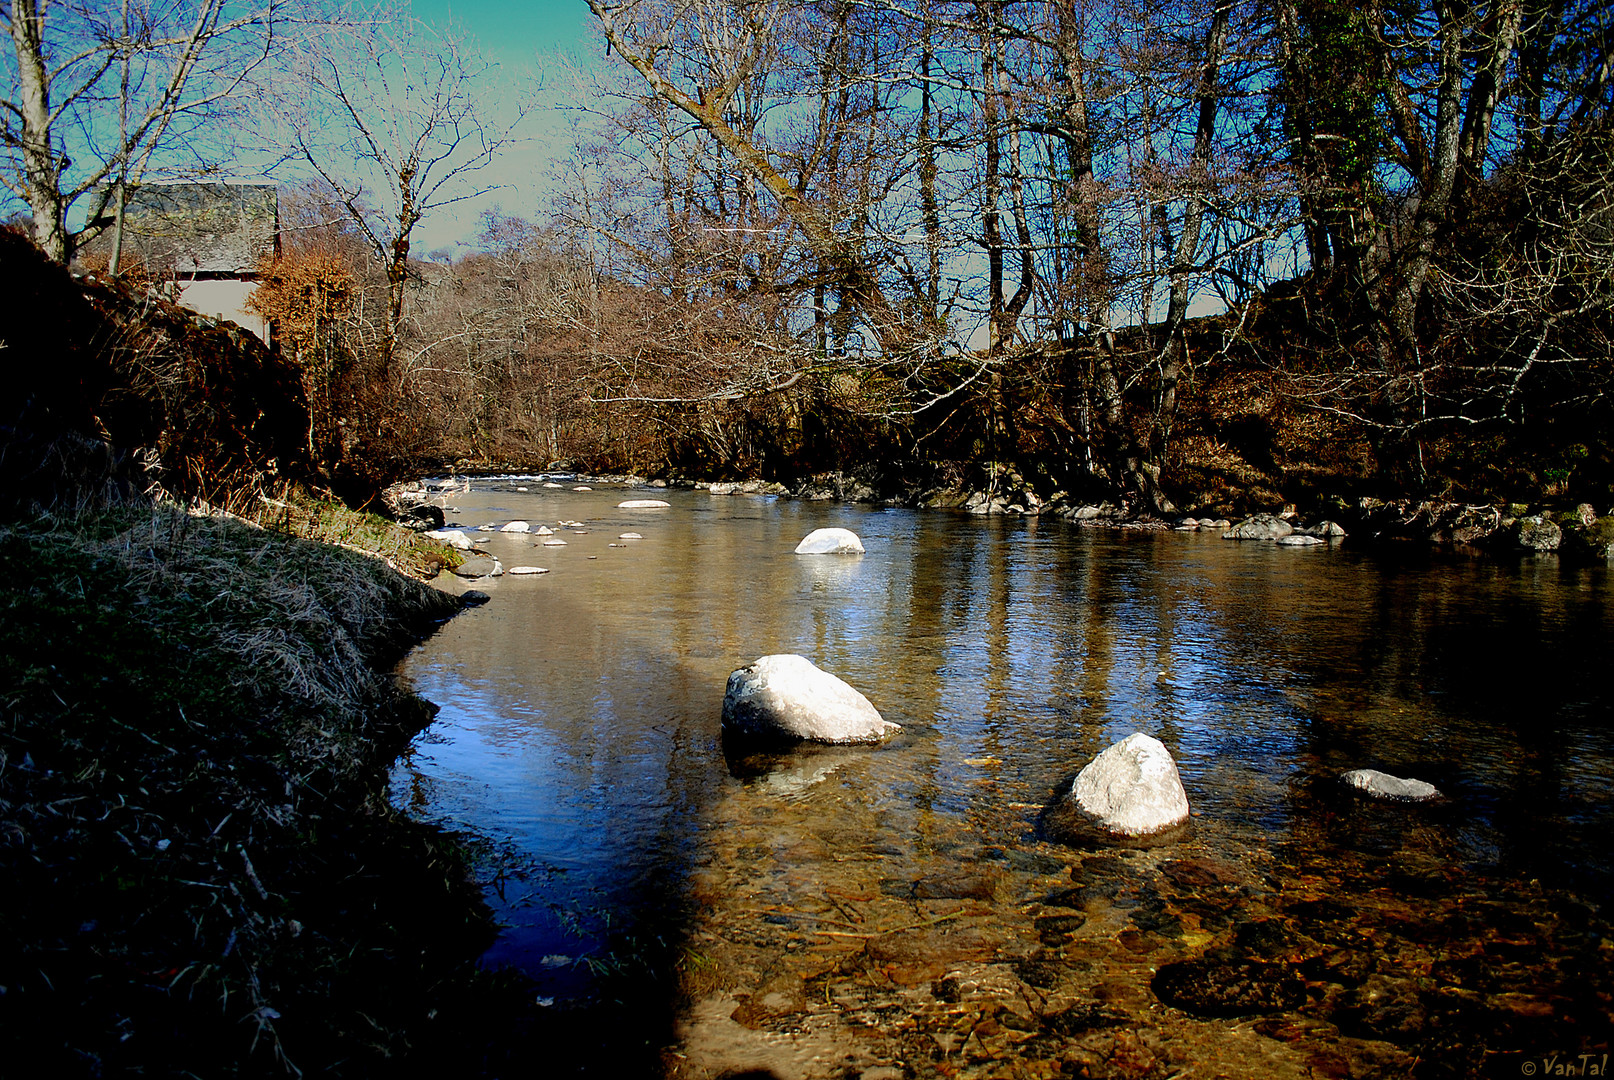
<box><xmin>723</xmin><ymin>654</ymin><xmax>902</xmax><ymax>743</ymax></box>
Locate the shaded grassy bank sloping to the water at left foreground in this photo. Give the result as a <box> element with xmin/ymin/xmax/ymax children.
<box><xmin>0</xmin><ymin>504</ymin><xmax>516</xmax><ymax>1077</ymax></box>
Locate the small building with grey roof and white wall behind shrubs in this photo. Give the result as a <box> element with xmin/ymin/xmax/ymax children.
<box><xmin>86</xmin><ymin>184</ymin><xmax>281</xmax><ymax>344</ymax></box>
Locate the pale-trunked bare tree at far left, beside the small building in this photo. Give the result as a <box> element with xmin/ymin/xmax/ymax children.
<box><xmin>0</xmin><ymin>0</ymin><xmax>286</xmax><ymax>262</ymax></box>
